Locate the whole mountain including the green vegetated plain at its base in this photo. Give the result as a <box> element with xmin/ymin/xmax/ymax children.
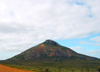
<box><xmin>0</xmin><ymin>40</ymin><xmax>100</xmax><ymax>72</ymax></box>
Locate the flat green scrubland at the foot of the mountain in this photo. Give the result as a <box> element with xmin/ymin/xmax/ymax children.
<box><xmin>1</xmin><ymin>59</ymin><xmax>100</xmax><ymax>72</ymax></box>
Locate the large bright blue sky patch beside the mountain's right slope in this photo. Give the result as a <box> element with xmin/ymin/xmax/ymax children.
<box><xmin>56</xmin><ymin>34</ymin><xmax>100</xmax><ymax>58</ymax></box>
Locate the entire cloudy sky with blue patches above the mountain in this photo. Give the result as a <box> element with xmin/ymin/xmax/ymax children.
<box><xmin>0</xmin><ymin>0</ymin><xmax>100</xmax><ymax>60</ymax></box>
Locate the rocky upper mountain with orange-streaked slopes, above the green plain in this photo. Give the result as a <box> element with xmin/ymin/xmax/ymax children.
<box><xmin>11</xmin><ymin>40</ymin><xmax>95</xmax><ymax>60</ymax></box>
